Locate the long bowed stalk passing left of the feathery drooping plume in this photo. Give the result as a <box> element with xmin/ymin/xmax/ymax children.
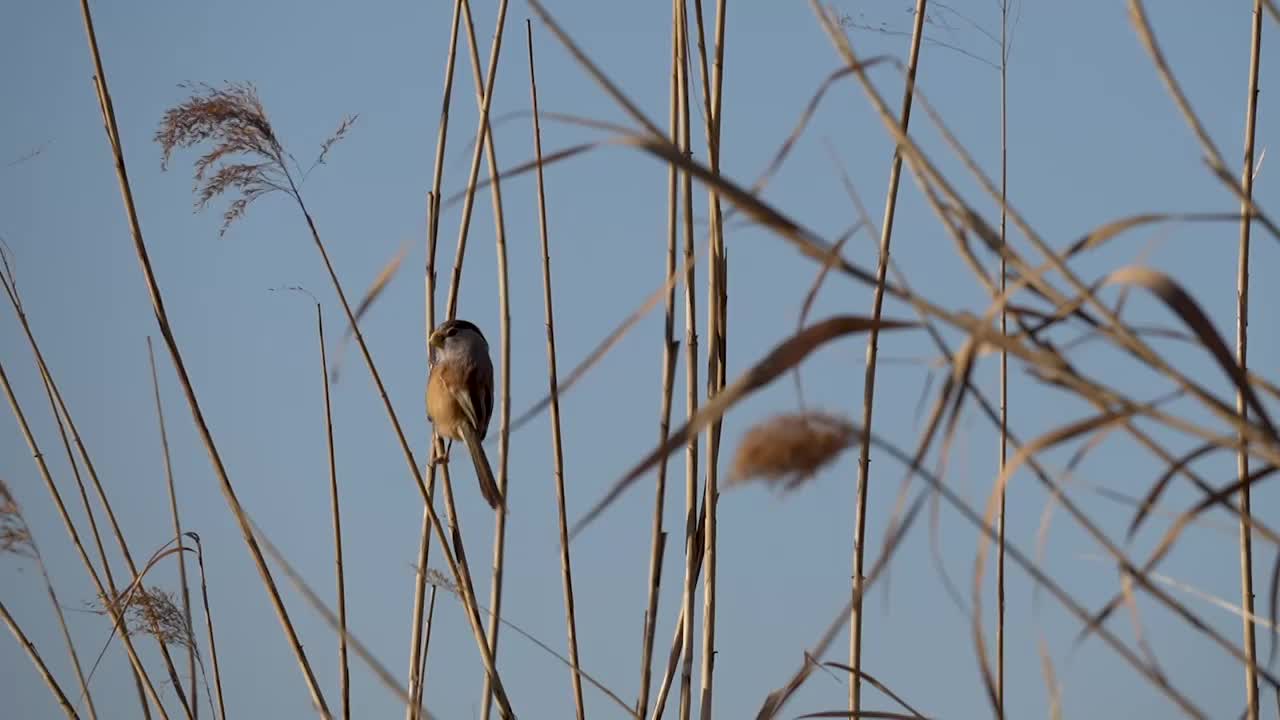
<box><xmin>81</xmin><ymin>0</ymin><xmax>332</xmax><ymax>717</ymax></box>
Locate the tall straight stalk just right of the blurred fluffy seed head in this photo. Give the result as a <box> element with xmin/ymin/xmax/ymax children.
<box><xmin>849</xmin><ymin>0</ymin><xmax>928</xmax><ymax>714</ymax></box>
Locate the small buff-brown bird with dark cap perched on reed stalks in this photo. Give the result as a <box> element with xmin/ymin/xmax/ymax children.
<box><xmin>426</xmin><ymin>319</ymin><xmax>503</xmax><ymax>510</ymax></box>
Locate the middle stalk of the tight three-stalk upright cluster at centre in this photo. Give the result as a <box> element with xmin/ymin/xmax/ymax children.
<box><xmin>676</xmin><ymin>0</ymin><xmax>703</xmax><ymax>720</ymax></box>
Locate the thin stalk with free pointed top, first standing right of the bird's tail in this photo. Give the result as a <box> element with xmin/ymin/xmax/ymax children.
<box><xmin>527</xmin><ymin>19</ymin><xmax>586</xmax><ymax>720</ymax></box>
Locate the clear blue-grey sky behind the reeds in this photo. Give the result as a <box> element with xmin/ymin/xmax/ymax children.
<box><xmin>0</xmin><ymin>0</ymin><xmax>1280</xmax><ymax>719</ymax></box>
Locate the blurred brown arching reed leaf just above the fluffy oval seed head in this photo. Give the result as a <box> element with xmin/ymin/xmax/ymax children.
<box><xmin>570</xmin><ymin>315</ymin><xmax>916</xmax><ymax>538</ymax></box>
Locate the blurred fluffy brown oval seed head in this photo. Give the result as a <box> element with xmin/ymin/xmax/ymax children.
<box><xmin>726</xmin><ymin>413</ymin><xmax>856</xmax><ymax>491</ymax></box>
